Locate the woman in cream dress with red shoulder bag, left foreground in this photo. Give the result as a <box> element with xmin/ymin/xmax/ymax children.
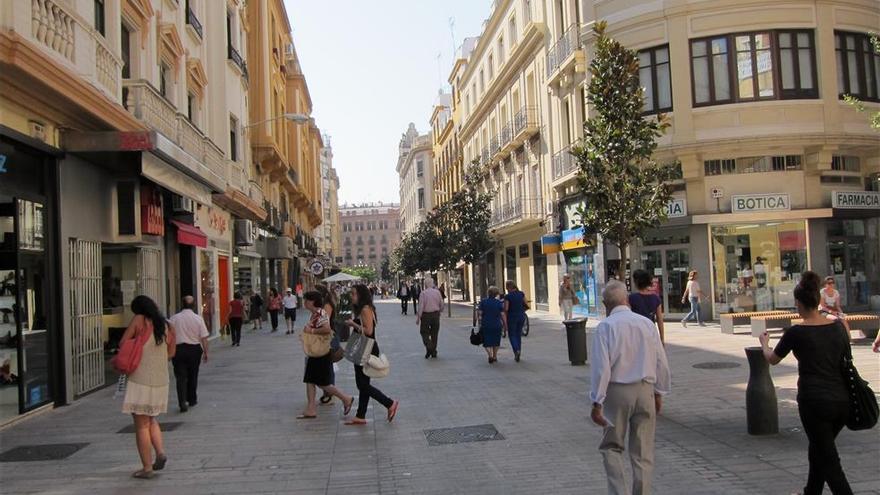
<box><xmin>114</xmin><ymin>296</ymin><xmax>175</xmax><ymax>479</ymax></box>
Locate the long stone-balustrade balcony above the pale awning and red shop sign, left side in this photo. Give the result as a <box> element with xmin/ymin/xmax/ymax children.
<box><xmin>123</xmin><ymin>80</ymin><xmax>228</xmax><ymax>189</ymax></box>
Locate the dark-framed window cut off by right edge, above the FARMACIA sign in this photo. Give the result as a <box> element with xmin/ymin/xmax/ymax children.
<box><xmin>834</xmin><ymin>31</ymin><xmax>880</xmax><ymax>101</ymax></box>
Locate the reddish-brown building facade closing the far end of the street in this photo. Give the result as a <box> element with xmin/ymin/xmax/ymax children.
<box><xmin>339</xmin><ymin>202</ymin><xmax>402</xmax><ymax>276</ymax></box>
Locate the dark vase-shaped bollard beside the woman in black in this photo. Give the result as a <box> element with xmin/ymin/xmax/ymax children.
<box><xmin>745</xmin><ymin>347</ymin><xmax>779</xmax><ymax>435</ymax></box>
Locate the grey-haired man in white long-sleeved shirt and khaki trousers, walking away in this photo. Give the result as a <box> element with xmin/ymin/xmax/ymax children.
<box><xmin>590</xmin><ymin>280</ymin><xmax>671</xmax><ymax>495</ymax></box>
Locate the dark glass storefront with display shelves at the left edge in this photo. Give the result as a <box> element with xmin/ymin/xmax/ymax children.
<box><xmin>0</xmin><ymin>127</ymin><xmax>64</xmax><ymax>424</ymax></box>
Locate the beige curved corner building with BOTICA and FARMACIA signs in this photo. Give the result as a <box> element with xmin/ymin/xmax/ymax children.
<box><xmin>547</xmin><ymin>0</ymin><xmax>880</xmax><ymax>316</ymax></box>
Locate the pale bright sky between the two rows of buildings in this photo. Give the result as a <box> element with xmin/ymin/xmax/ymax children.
<box><xmin>284</xmin><ymin>0</ymin><xmax>491</xmax><ymax>205</ymax></box>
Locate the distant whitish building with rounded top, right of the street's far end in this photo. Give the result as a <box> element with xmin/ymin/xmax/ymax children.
<box><xmin>397</xmin><ymin>123</ymin><xmax>434</xmax><ymax>234</ymax></box>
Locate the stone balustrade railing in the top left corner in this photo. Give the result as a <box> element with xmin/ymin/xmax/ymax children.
<box><xmin>26</xmin><ymin>0</ymin><xmax>122</xmax><ymax>102</ymax></box>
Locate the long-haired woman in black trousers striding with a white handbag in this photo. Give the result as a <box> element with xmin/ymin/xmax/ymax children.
<box><xmin>345</xmin><ymin>284</ymin><xmax>399</xmax><ymax>425</ymax></box>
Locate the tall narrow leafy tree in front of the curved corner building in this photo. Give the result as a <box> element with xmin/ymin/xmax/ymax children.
<box><xmin>572</xmin><ymin>21</ymin><xmax>677</xmax><ymax>280</ymax></box>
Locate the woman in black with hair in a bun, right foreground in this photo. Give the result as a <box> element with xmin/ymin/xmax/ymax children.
<box><xmin>760</xmin><ymin>272</ymin><xmax>852</xmax><ymax>495</ymax></box>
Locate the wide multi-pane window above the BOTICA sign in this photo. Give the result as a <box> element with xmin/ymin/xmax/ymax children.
<box><xmin>691</xmin><ymin>30</ymin><xmax>819</xmax><ymax>106</ymax></box>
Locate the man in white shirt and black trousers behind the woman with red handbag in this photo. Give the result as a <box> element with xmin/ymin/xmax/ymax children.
<box><xmin>168</xmin><ymin>296</ymin><xmax>209</xmax><ymax>412</ymax></box>
